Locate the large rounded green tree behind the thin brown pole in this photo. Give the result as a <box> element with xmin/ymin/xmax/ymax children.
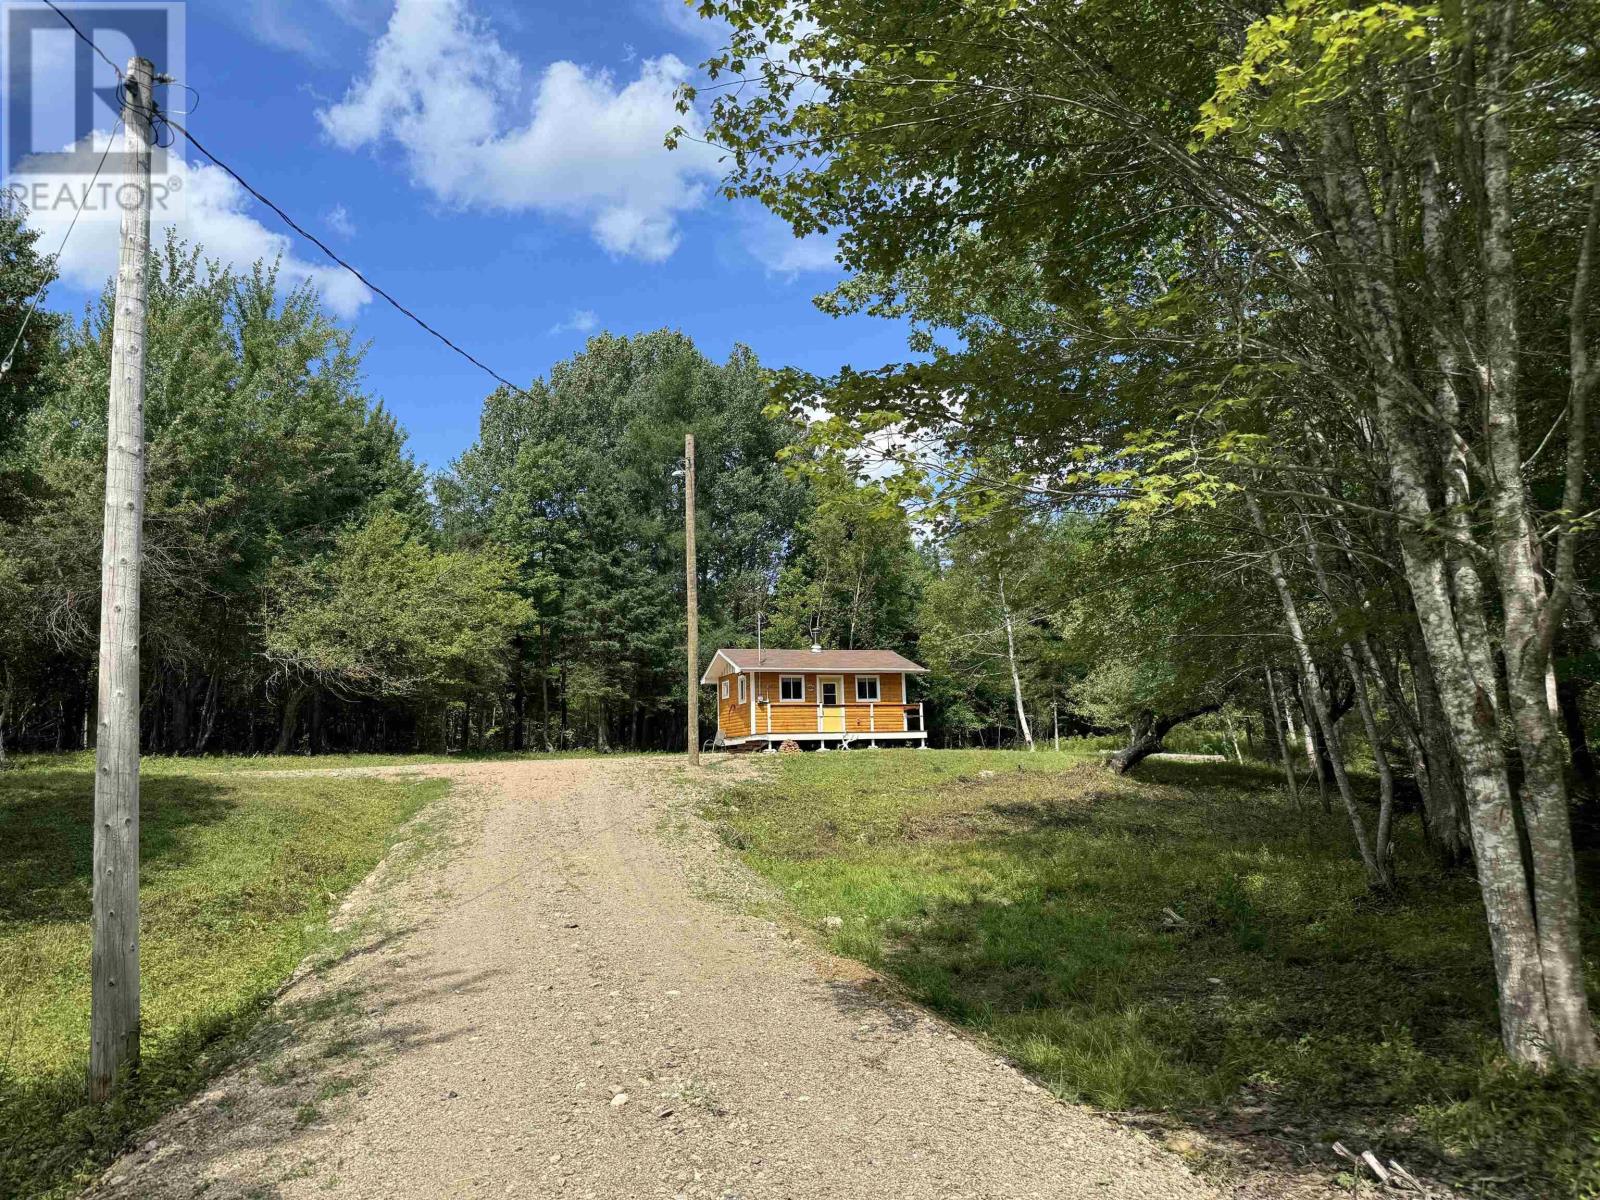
<box><xmin>438</xmin><ymin>331</ymin><xmax>806</xmax><ymax>747</ymax></box>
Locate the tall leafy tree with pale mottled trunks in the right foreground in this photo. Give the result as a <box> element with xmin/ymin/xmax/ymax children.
<box><xmin>683</xmin><ymin>0</ymin><xmax>1600</xmax><ymax>1066</ymax></box>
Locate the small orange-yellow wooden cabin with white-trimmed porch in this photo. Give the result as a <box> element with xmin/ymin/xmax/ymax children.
<box><xmin>701</xmin><ymin>648</ymin><xmax>928</xmax><ymax>749</ymax></box>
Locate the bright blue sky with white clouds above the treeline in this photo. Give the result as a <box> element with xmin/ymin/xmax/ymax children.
<box><xmin>25</xmin><ymin>0</ymin><xmax>906</xmax><ymax>469</ymax></box>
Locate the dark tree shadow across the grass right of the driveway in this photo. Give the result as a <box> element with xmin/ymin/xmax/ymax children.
<box><xmin>870</xmin><ymin>876</ymin><xmax>1600</xmax><ymax>1200</ymax></box>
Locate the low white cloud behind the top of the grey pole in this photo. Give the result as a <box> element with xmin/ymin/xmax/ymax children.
<box><xmin>16</xmin><ymin>133</ymin><xmax>371</xmax><ymax>318</ymax></box>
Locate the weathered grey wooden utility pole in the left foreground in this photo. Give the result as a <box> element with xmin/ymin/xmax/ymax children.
<box><xmin>90</xmin><ymin>58</ymin><xmax>155</xmax><ymax>1101</ymax></box>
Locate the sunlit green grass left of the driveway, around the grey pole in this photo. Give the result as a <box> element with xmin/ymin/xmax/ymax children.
<box><xmin>0</xmin><ymin>755</ymin><xmax>448</xmax><ymax>1197</ymax></box>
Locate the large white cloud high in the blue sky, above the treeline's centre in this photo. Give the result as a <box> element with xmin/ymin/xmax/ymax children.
<box><xmin>318</xmin><ymin>0</ymin><xmax>720</xmax><ymax>262</ymax></box>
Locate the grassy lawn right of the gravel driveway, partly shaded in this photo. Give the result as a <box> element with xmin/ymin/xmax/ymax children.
<box><xmin>707</xmin><ymin>750</ymin><xmax>1600</xmax><ymax>1197</ymax></box>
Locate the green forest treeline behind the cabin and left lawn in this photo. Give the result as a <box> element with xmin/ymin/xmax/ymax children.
<box><xmin>0</xmin><ymin>219</ymin><xmax>1100</xmax><ymax>754</ymax></box>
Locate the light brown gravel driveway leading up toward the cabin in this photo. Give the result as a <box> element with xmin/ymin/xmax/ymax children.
<box><xmin>93</xmin><ymin>760</ymin><xmax>1214</xmax><ymax>1200</ymax></box>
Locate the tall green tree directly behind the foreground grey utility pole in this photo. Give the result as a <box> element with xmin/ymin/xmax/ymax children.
<box><xmin>0</xmin><ymin>240</ymin><xmax>427</xmax><ymax>752</ymax></box>
